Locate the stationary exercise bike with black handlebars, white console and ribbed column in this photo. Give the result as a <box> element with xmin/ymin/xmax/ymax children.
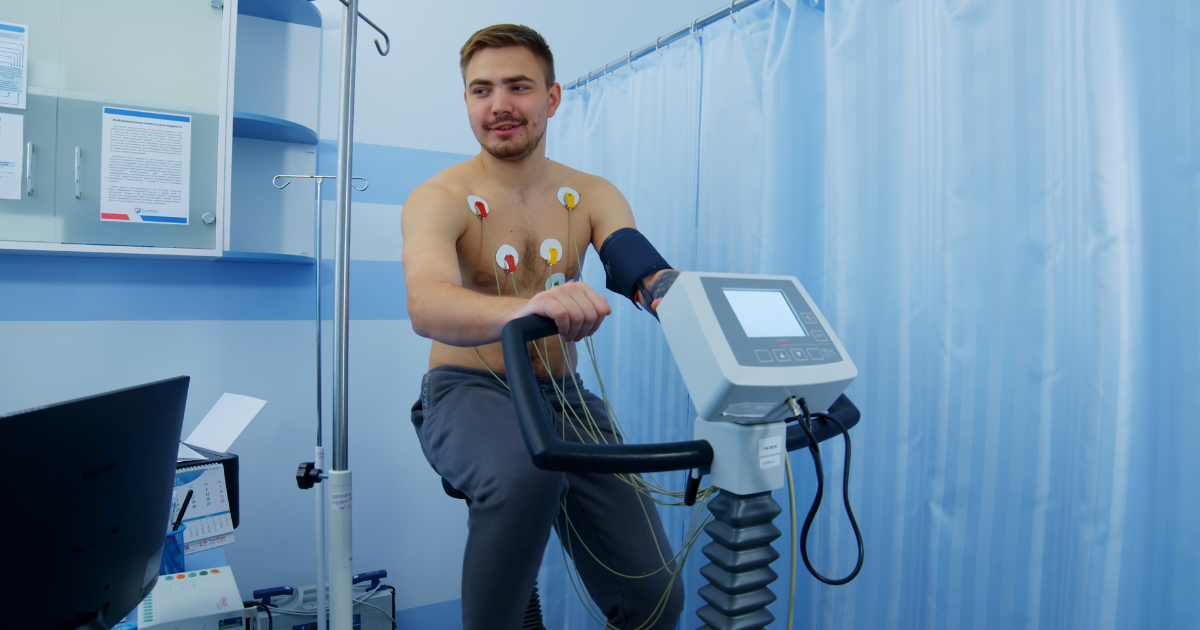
<box><xmin>503</xmin><ymin>272</ymin><xmax>862</xmax><ymax>630</ymax></box>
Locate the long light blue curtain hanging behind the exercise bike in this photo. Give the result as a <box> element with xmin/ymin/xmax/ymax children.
<box><xmin>542</xmin><ymin>0</ymin><xmax>1200</xmax><ymax>630</ymax></box>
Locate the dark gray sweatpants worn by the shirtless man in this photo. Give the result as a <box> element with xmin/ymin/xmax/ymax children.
<box><xmin>413</xmin><ymin>366</ymin><xmax>684</xmax><ymax>630</ymax></box>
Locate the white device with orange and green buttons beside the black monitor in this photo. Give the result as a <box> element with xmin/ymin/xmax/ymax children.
<box><xmin>137</xmin><ymin>566</ymin><xmax>246</xmax><ymax>630</ymax></box>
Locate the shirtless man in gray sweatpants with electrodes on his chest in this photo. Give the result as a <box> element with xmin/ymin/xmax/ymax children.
<box><xmin>402</xmin><ymin>24</ymin><xmax>683</xmax><ymax>630</ymax></box>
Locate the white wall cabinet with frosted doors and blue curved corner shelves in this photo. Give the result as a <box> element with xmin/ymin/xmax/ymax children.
<box><xmin>0</xmin><ymin>0</ymin><xmax>320</xmax><ymax>262</ymax></box>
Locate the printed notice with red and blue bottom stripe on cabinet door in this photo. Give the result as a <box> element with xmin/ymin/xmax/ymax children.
<box><xmin>100</xmin><ymin>107</ymin><xmax>192</xmax><ymax>226</ymax></box>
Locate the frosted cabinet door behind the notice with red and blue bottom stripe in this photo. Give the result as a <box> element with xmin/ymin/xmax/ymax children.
<box><xmin>55</xmin><ymin>0</ymin><xmax>222</xmax><ymax>248</ymax></box>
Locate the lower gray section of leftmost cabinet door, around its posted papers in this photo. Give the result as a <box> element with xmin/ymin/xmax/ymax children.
<box><xmin>0</xmin><ymin>94</ymin><xmax>59</xmax><ymax>242</ymax></box>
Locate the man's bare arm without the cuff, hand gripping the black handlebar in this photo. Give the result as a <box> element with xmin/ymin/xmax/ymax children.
<box><xmin>401</xmin><ymin>184</ymin><xmax>612</xmax><ymax>347</ymax></box>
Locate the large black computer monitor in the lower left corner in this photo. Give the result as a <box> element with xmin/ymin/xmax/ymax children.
<box><xmin>0</xmin><ymin>377</ymin><xmax>188</xmax><ymax>630</ymax></box>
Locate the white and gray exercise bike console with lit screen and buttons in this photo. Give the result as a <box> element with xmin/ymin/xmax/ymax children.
<box><xmin>658</xmin><ymin>271</ymin><xmax>858</xmax><ymax>424</ymax></box>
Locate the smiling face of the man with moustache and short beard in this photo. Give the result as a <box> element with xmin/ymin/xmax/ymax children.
<box><xmin>463</xmin><ymin>46</ymin><xmax>562</xmax><ymax>162</ymax></box>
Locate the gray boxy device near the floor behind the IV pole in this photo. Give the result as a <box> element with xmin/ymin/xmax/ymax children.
<box><xmin>246</xmin><ymin>571</ymin><xmax>396</xmax><ymax>630</ymax></box>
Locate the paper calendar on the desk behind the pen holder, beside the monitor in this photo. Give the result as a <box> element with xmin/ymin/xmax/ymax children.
<box><xmin>167</xmin><ymin>463</ymin><xmax>233</xmax><ymax>553</ymax></box>
